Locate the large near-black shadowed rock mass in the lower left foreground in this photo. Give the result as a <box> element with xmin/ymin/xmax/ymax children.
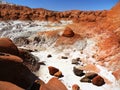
<box><xmin>0</xmin><ymin>60</ymin><xmax>38</xmax><ymax>89</ymax></box>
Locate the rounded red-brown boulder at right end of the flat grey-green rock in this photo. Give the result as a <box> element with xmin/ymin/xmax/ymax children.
<box><xmin>92</xmin><ymin>75</ymin><xmax>105</xmax><ymax>86</ymax></box>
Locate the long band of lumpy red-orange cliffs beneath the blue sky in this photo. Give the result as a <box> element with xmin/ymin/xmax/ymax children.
<box><xmin>0</xmin><ymin>4</ymin><xmax>108</xmax><ymax>22</ymax></box>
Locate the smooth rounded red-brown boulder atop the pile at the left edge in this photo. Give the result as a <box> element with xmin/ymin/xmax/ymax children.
<box><xmin>0</xmin><ymin>38</ymin><xmax>19</xmax><ymax>56</ymax></box>
